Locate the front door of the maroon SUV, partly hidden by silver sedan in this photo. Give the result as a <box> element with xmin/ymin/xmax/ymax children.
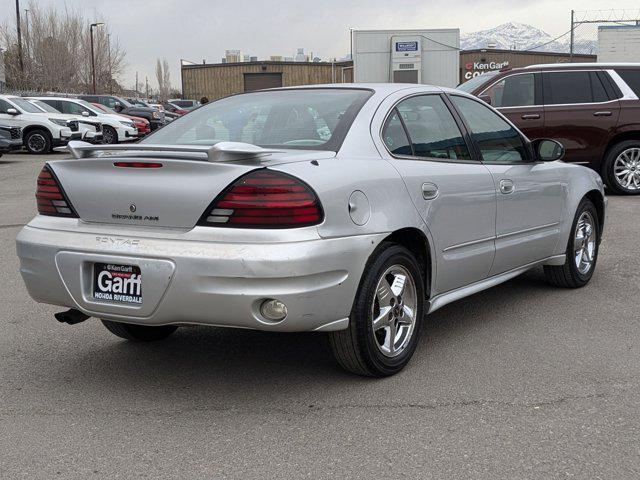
<box><xmin>480</xmin><ymin>71</ymin><xmax>544</xmax><ymax>140</ymax></box>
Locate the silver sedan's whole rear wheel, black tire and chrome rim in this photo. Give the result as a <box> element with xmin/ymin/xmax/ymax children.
<box><xmin>329</xmin><ymin>242</ymin><xmax>425</xmax><ymax>377</ymax></box>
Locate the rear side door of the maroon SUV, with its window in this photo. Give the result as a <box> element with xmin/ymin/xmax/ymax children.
<box><xmin>542</xmin><ymin>70</ymin><xmax>620</xmax><ymax>165</ymax></box>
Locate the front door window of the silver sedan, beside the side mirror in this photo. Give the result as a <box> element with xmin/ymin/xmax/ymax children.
<box><xmin>451</xmin><ymin>95</ymin><xmax>529</xmax><ymax>163</ymax></box>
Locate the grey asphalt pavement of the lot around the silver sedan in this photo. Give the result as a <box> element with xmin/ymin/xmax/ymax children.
<box><xmin>0</xmin><ymin>154</ymin><xmax>640</xmax><ymax>480</ymax></box>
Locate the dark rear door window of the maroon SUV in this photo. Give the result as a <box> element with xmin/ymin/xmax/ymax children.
<box><xmin>543</xmin><ymin>72</ymin><xmax>609</xmax><ymax>105</ymax></box>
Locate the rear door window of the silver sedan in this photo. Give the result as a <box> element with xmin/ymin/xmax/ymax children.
<box><xmin>383</xmin><ymin>95</ymin><xmax>471</xmax><ymax>160</ymax></box>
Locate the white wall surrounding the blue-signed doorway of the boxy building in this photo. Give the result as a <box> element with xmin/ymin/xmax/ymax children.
<box><xmin>352</xmin><ymin>28</ymin><xmax>460</xmax><ymax>87</ymax></box>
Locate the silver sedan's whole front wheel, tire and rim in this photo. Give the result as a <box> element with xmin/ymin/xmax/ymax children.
<box><xmin>544</xmin><ymin>198</ymin><xmax>600</xmax><ymax>288</ymax></box>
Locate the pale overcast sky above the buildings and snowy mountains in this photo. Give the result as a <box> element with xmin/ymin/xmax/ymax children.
<box><xmin>0</xmin><ymin>0</ymin><xmax>638</xmax><ymax>87</ymax></box>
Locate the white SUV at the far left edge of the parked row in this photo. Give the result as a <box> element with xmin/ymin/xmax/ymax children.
<box><xmin>0</xmin><ymin>95</ymin><xmax>82</xmax><ymax>153</ymax></box>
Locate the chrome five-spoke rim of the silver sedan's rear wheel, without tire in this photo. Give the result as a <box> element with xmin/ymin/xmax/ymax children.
<box><xmin>371</xmin><ymin>265</ymin><xmax>418</xmax><ymax>357</ymax></box>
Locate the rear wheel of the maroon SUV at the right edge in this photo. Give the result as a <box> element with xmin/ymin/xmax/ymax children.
<box><xmin>602</xmin><ymin>140</ymin><xmax>640</xmax><ymax>195</ymax></box>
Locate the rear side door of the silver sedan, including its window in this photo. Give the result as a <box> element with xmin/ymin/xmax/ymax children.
<box><xmin>382</xmin><ymin>94</ymin><xmax>496</xmax><ymax>294</ymax></box>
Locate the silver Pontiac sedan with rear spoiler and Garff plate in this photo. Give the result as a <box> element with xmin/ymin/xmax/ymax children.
<box><xmin>17</xmin><ymin>84</ymin><xmax>606</xmax><ymax>376</ymax></box>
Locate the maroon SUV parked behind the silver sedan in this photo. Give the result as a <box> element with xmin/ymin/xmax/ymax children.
<box><xmin>458</xmin><ymin>63</ymin><xmax>640</xmax><ymax>194</ymax></box>
